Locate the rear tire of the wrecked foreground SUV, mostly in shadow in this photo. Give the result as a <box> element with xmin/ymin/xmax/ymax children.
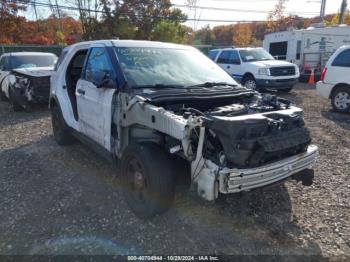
<box><xmin>51</xmin><ymin>105</ymin><xmax>74</xmax><ymax>146</ymax></box>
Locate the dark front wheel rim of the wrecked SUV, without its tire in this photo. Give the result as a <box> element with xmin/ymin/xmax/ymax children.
<box><xmin>126</xmin><ymin>156</ymin><xmax>147</xmax><ymax>203</ymax></box>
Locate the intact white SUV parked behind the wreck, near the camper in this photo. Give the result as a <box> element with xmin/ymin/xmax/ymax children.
<box><xmin>208</xmin><ymin>48</ymin><xmax>299</xmax><ymax>92</ymax></box>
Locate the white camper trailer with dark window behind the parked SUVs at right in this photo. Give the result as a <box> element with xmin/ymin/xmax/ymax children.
<box><xmin>263</xmin><ymin>25</ymin><xmax>350</xmax><ymax>80</ymax></box>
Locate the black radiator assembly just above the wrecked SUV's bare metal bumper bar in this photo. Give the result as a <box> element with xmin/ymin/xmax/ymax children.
<box><xmin>208</xmin><ymin>109</ymin><xmax>311</xmax><ymax>168</ymax></box>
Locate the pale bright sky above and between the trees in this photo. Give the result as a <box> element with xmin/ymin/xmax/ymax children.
<box><xmin>25</xmin><ymin>0</ymin><xmax>344</xmax><ymax>29</ymax></box>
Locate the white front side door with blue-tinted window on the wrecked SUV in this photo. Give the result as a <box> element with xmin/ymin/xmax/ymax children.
<box><xmin>76</xmin><ymin>46</ymin><xmax>116</xmax><ymax>151</ymax></box>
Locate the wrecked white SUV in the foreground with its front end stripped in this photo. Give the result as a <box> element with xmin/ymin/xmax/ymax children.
<box><xmin>50</xmin><ymin>40</ymin><xmax>318</xmax><ymax>218</ymax></box>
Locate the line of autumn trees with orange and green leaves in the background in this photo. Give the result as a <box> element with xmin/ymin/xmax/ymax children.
<box><xmin>0</xmin><ymin>0</ymin><xmax>350</xmax><ymax>46</ymax></box>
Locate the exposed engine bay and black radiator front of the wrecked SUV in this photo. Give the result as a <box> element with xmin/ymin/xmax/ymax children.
<box><xmin>157</xmin><ymin>94</ymin><xmax>311</xmax><ymax>168</ymax></box>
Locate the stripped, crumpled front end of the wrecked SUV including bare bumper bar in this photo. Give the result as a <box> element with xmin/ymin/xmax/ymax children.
<box><xmin>119</xmin><ymin>91</ymin><xmax>318</xmax><ymax>201</ymax></box>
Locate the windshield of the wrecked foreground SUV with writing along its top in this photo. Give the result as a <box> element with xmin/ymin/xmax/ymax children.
<box><xmin>115</xmin><ymin>47</ymin><xmax>237</xmax><ymax>88</ymax></box>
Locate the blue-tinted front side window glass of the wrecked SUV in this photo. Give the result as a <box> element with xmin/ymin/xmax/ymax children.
<box><xmin>85</xmin><ymin>47</ymin><xmax>112</xmax><ymax>83</ymax></box>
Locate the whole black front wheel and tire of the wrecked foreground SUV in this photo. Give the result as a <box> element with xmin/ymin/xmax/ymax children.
<box><xmin>120</xmin><ymin>143</ymin><xmax>175</xmax><ymax>219</ymax></box>
